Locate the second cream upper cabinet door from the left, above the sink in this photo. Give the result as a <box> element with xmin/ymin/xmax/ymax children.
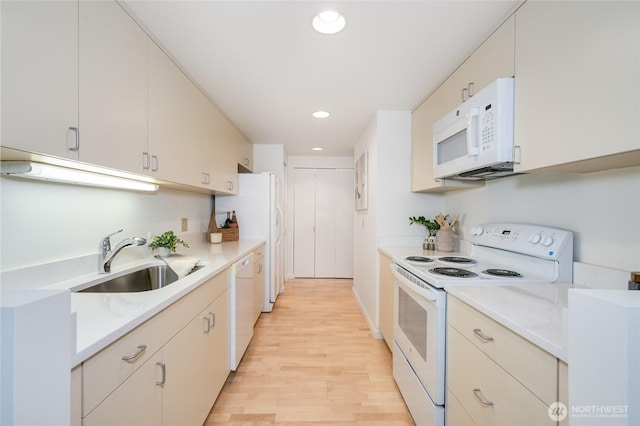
<box><xmin>79</xmin><ymin>1</ymin><xmax>147</xmax><ymax>172</ymax></box>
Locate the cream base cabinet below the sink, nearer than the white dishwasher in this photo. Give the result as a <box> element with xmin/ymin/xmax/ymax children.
<box><xmin>82</xmin><ymin>271</ymin><xmax>229</xmax><ymax>426</ymax></box>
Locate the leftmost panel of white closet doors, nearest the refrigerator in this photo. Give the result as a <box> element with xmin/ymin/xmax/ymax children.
<box><xmin>293</xmin><ymin>169</ymin><xmax>316</xmax><ymax>277</ymax></box>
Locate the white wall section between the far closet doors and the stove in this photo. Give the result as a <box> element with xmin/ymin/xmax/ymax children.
<box><xmin>353</xmin><ymin>111</ymin><xmax>443</xmax><ymax>337</ymax></box>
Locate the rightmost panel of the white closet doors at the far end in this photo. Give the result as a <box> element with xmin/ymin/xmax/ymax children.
<box><xmin>335</xmin><ymin>169</ymin><xmax>355</xmax><ymax>278</ymax></box>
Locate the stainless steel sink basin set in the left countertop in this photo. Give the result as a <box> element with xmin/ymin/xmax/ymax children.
<box><xmin>78</xmin><ymin>265</ymin><xmax>204</xmax><ymax>293</ymax></box>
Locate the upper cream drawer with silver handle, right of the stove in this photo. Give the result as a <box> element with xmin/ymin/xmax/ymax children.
<box><xmin>447</xmin><ymin>297</ymin><xmax>558</xmax><ymax>404</ymax></box>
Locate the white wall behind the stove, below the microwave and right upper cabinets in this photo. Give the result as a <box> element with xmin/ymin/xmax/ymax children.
<box><xmin>444</xmin><ymin>167</ymin><xmax>640</xmax><ymax>271</ymax></box>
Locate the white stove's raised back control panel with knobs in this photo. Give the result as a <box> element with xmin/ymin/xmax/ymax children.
<box><xmin>471</xmin><ymin>223</ymin><xmax>573</xmax><ymax>259</ymax></box>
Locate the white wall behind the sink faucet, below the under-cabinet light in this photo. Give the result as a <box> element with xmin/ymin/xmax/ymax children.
<box><xmin>0</xmin><ymin>177</ymin><xmax>211</xmax><ymax>271</ymax></box>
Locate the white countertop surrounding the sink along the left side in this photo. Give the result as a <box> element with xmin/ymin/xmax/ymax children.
<box><xmin>2</xmin><ymin>240</ymin><xmax>264</xmax><ymax>368</ymax></box>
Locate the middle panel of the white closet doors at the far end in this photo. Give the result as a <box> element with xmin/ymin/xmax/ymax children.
<box><xmin>315</xmin><ymin>169</ymin><xmax>336</xmax><ymax>278</ymax></box>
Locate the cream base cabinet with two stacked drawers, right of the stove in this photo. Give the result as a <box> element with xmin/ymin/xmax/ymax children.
<box><xmin>446</xmin><ymin>297</ymin><xmax>558</xmax><ymax>426</ymax></box>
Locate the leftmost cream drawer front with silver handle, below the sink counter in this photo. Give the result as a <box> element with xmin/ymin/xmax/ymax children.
<box><xmin>82</xmin><ymin>306</ymin><xmax>170</xmax><ymax>417</ymax></box>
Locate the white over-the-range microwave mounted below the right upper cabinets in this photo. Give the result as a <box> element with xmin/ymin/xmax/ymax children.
<box><xmin>433</xmin><ymin>78</ymin><xmax>514</xmax><ymax>180</ymax></box>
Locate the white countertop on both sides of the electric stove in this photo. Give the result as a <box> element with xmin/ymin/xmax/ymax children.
<box><xmin>378</xmin><ymin>245</ymin><xmax>574</xmax><ymax>362</ymax></box>
